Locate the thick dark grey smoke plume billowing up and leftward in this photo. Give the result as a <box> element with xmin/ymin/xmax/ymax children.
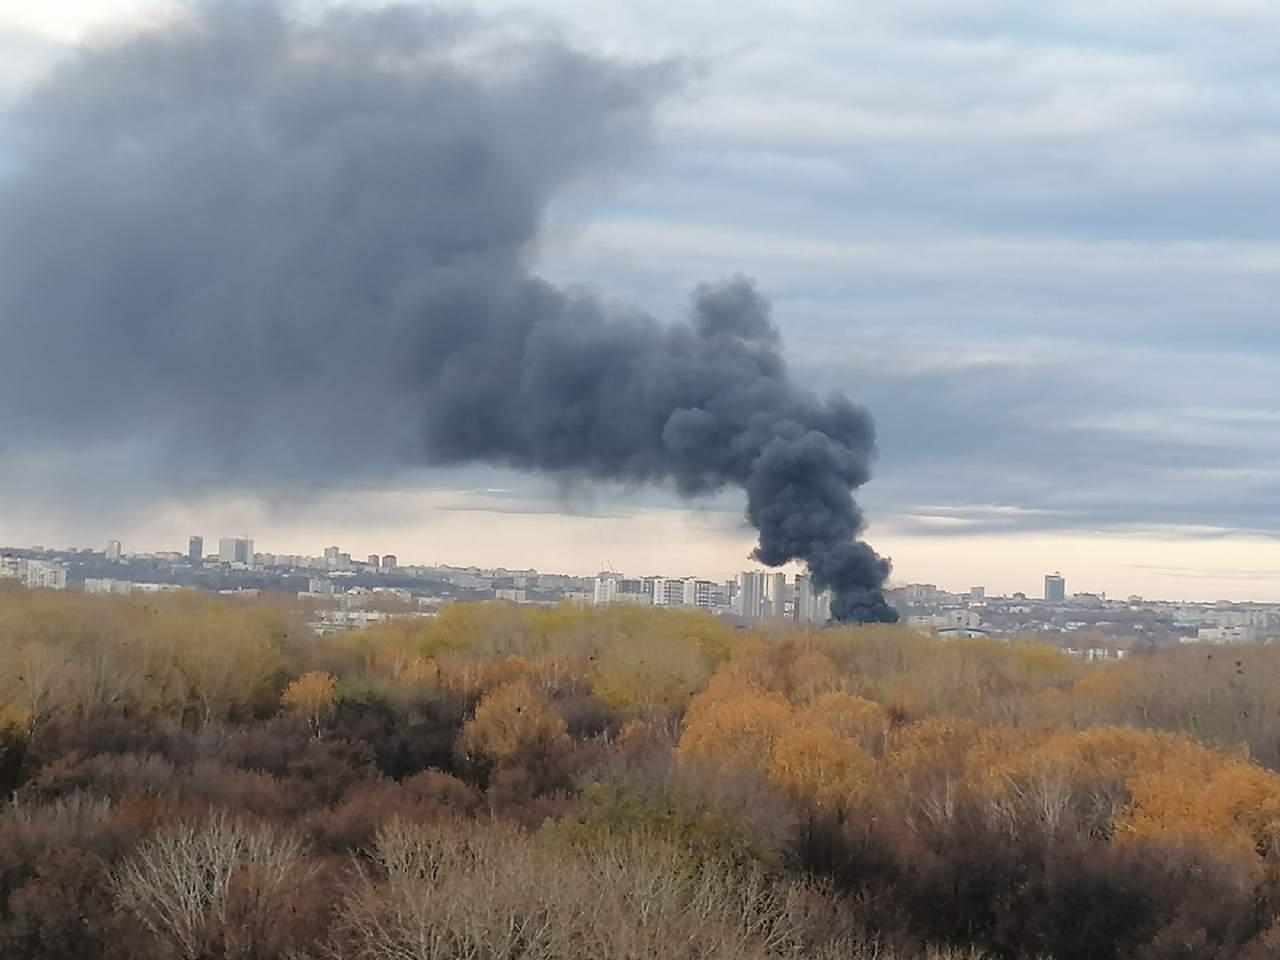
<box><xmin>0</xmin><ymin>4</ymin><xmax>893</xmax><ymax>621</ymax></box>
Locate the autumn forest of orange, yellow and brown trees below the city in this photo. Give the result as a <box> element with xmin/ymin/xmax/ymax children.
<box><xmin>0</xmin><ymin>586</ymin><xmax>1280</xmax><ymax>960</ymax></box>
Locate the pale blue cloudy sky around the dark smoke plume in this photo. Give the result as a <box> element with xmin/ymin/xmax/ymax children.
<box><xmin>0</xmin><ymin>0</ymin><xmax>1280</xmax><ymax>600</ymax></box>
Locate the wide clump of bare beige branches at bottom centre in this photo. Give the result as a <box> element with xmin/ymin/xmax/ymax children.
<box><xmin>335</xmin><ymin>820</ymin><xmax>880</xmax><ymax>960</ymax></box>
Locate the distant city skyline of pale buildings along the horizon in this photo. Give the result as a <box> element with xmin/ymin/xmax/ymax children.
<box><xmin>0</xmin><ymin>536</ymin><xmax>1280</xmax><ymax>659</ymax></box>
